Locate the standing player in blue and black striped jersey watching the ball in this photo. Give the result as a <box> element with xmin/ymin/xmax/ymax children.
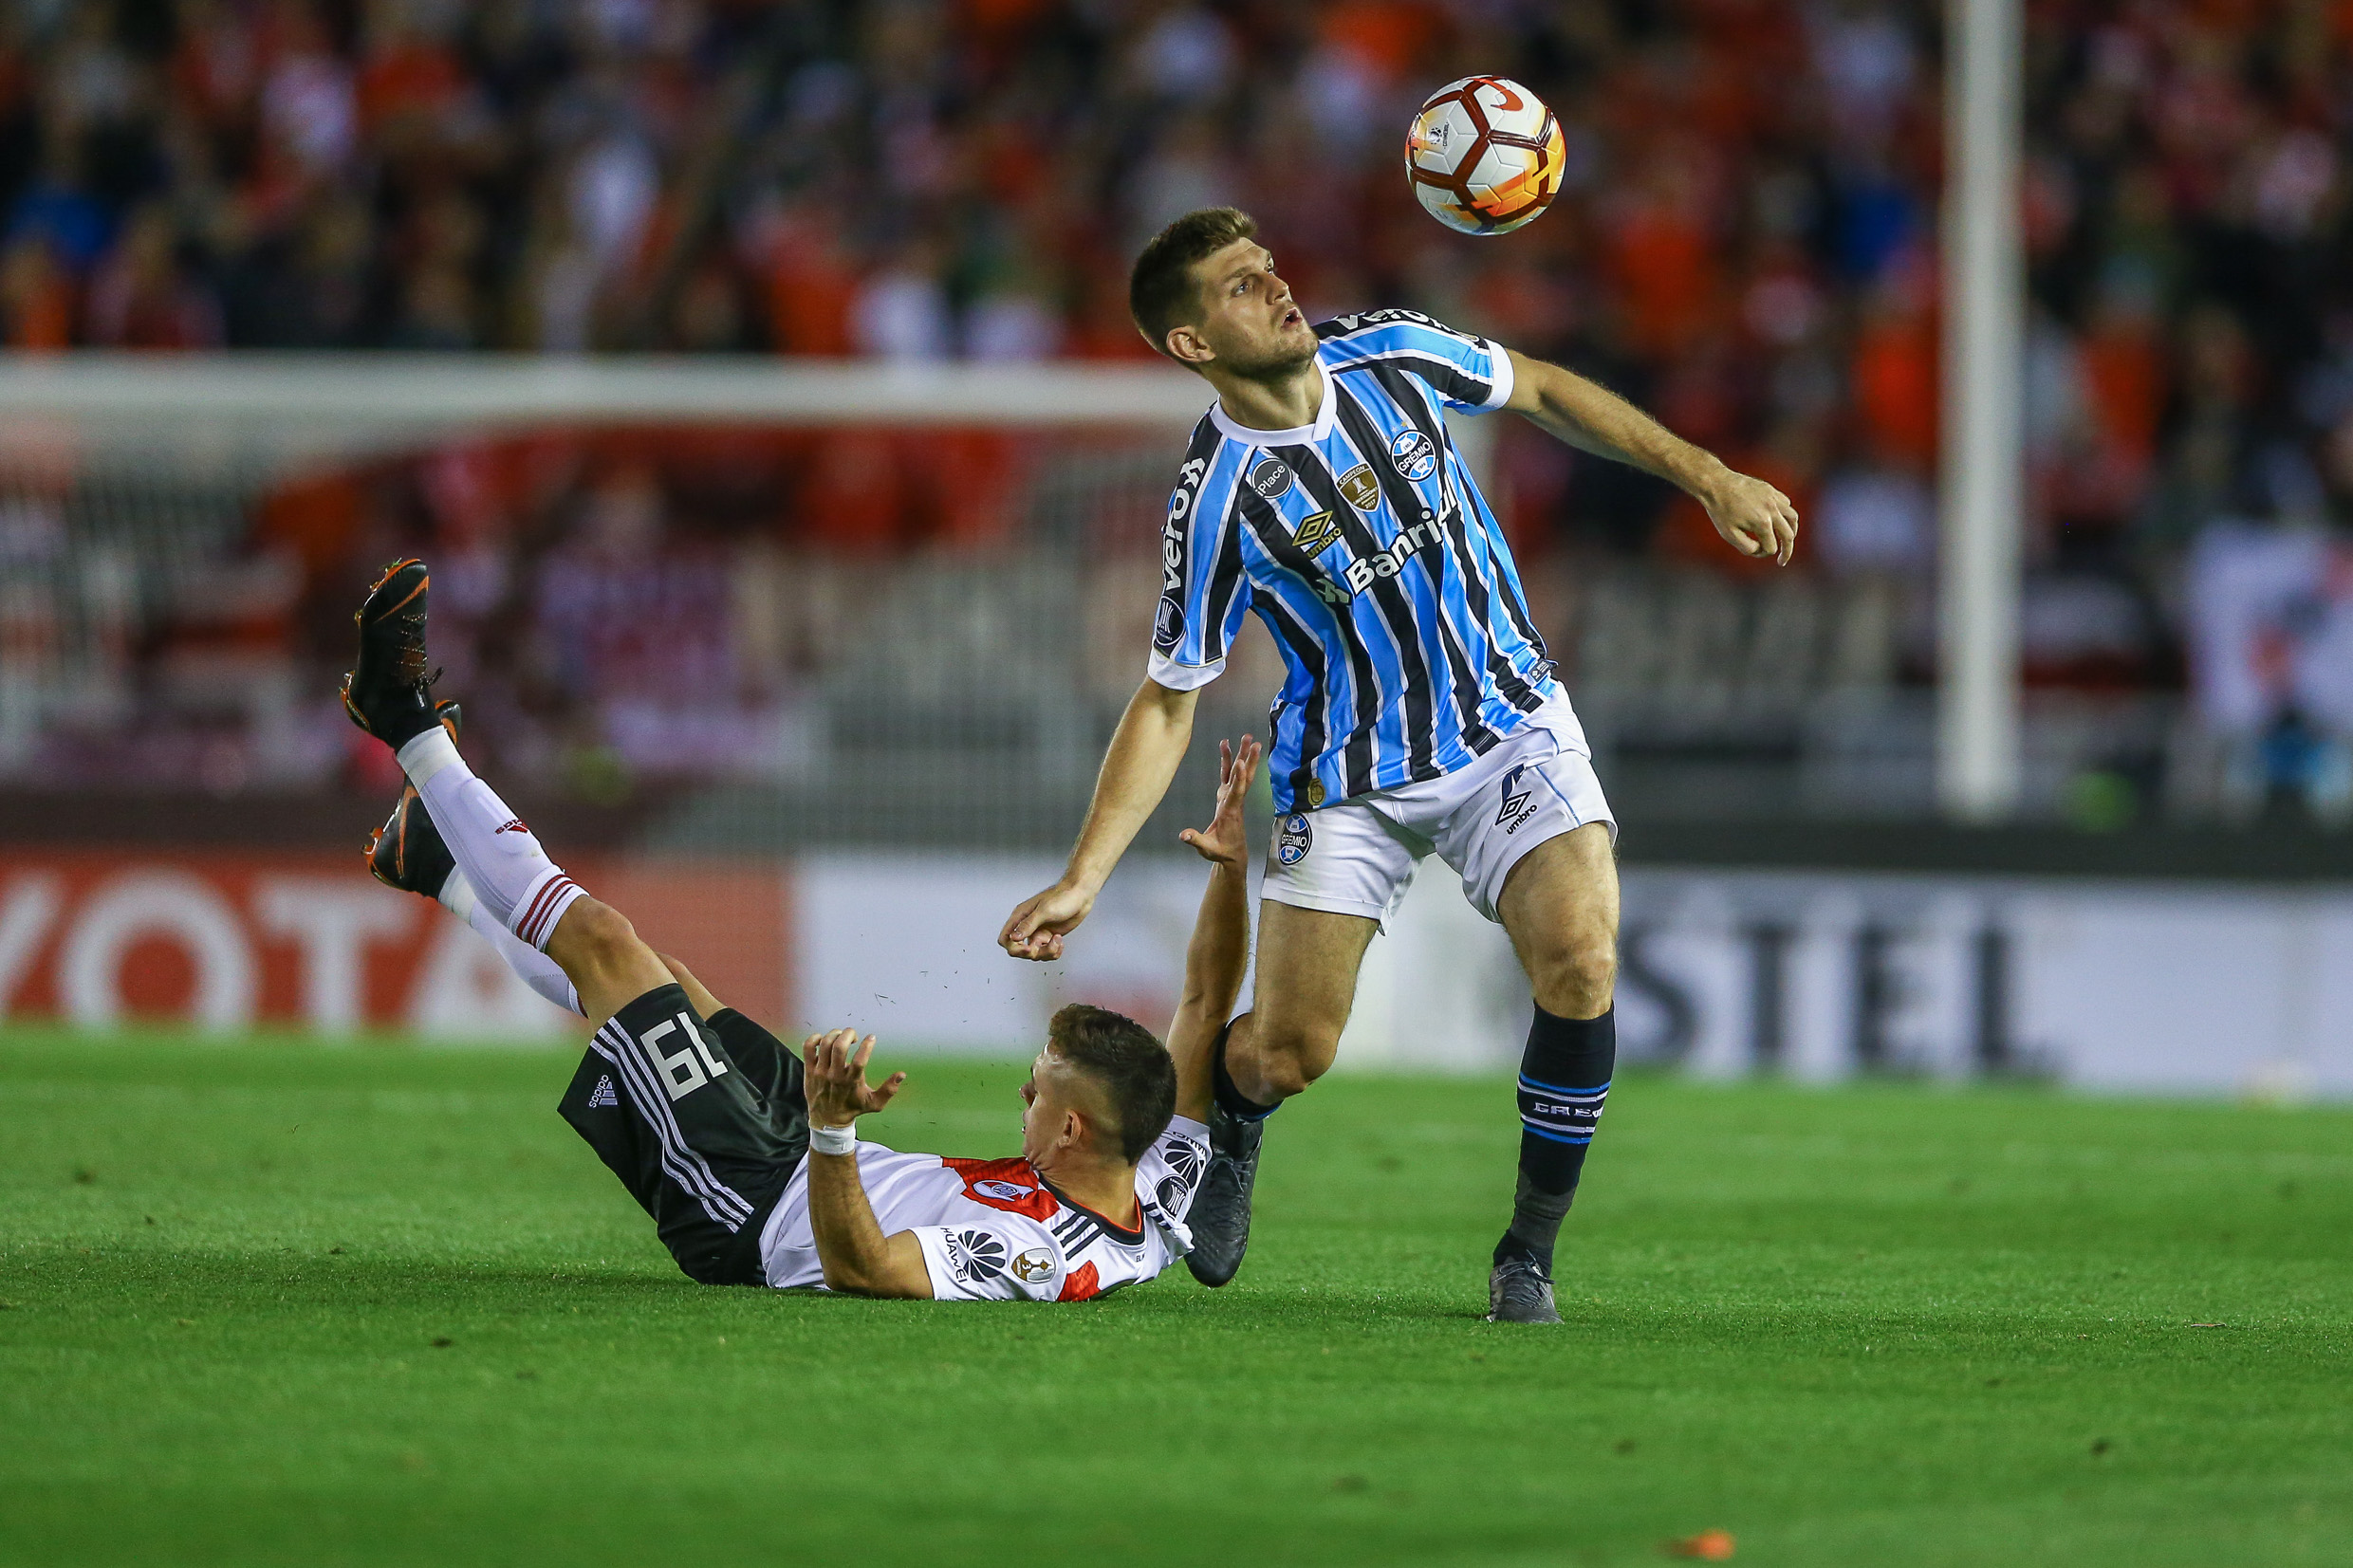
<box><xmin>998</xmin><ymin>207</ymin><xmax>1798</xmax><ymax>1323</ymax></box>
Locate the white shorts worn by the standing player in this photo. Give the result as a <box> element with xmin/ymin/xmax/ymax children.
<box><xmin>1261</xmin><ymin>698</ymin><xmax>1617</xmax><ymax>929</ymax></box>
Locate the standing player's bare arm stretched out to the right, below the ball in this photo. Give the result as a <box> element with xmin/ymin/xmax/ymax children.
<box><xmin>1504</xmin><ymin>350</ymin><xmax>1798</xmax><ymax>566</ymax></box>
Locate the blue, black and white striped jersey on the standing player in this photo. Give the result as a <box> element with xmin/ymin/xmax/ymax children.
<box><xmin>1151</xmin><ymin>310</ymin><xmax>1558</xmax><ymax>811</ymax></box>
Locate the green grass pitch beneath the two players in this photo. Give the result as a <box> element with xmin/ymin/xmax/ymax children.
<box><xmin>0</xmin><ymin>1032</ymin><xmax>2353</xmax><ymax>1568</ymax></box>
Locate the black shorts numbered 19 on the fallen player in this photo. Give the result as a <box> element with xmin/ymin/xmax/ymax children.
<box><xmin>558</xmin><ymin>985</ymin><xmax>809</xmax><ymax>1286</ymax></box>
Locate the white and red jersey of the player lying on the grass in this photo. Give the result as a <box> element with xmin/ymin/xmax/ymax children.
<box><xmin>760</xmin><ymin>1116</ymin><xmax>1210</xmax><ymax>1302</ymax></box>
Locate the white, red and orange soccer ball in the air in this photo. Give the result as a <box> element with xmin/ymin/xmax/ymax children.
<box><xmin>1405</xmin><ymin>75</ymin><xmax>1567</xmax><ymax>235</ymax></box>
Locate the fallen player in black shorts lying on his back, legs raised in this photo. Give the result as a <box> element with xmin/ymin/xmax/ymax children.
<box><xmin>343</xmin><ymin>562</ymin><xmax>1259</xmax><ymax>1302</ymax></box>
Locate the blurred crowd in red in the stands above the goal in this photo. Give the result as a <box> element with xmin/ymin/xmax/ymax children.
<box><xmin>0</xmin><ymin>0</ymin><xmax>2353</xmax><ymax>822</ymax></box>
